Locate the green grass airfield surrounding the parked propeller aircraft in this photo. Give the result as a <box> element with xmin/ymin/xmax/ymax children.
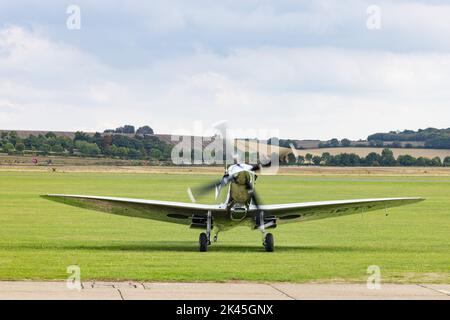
<box><xmin>0</xmin><ymin>172</ymin><xmax>450</xmax><ymax>283</ymax></box>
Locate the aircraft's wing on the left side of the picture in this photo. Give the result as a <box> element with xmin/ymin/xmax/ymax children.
<box><xmin>41</xmin><ymin>194</ymin><xmax>226</xmax><ymax>225</ymax></box>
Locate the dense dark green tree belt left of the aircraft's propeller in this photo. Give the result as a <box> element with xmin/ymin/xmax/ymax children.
<box><xmin>0</xmin><ymin>126</ymin><xmax>172</xmax><ymax>160</ymax></box>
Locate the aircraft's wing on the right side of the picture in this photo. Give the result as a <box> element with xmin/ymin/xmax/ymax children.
<box><xmin>252</xmin><ymin>198</ymin><xmax>425</xmax><ymax>223</ymax></box>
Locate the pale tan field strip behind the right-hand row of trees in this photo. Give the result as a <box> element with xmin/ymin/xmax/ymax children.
<box><xmin>297</xmin><ymin>147</ymin><xmax>450</xmax><ymax>159</ymax></box>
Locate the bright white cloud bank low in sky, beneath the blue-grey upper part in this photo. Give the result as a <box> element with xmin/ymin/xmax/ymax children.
<box><xmin>0</xmin><ymin>26</ymin><xmax>450</xmax><ymax>138</ymax></box>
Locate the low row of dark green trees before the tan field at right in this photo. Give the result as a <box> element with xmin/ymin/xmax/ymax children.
<box><xmin>282</xmin><ymin>148</ymin><xmax>450</xmax><ymax>167</ymax></box>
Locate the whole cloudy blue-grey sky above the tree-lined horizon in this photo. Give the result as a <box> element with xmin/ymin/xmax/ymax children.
<box><xmin>0</xmin><ymin>0</ymin><xmax>450</xmax><ymax>139</ymax></box>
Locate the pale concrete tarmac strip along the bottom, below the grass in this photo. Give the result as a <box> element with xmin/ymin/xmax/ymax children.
<box><xmin>0</xmin><ymin>281</ymin><xmax>450</xmax><ymax>300</ymax></box>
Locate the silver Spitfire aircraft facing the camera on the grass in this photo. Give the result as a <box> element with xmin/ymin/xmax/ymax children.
<box><xmin>42</xmin><ymin>164</ymin><xmax>424</xmax><ymax>252</ymax></box>
